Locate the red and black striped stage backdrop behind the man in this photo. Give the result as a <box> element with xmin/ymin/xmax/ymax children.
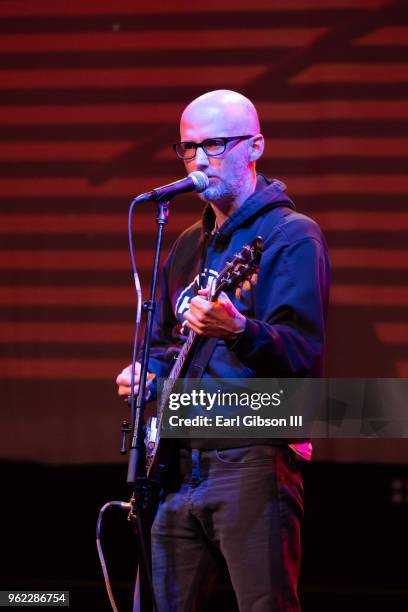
<box><xmin>0</xmin><ymin>0</ymin><xmax>408</xmax><ymax>462</ymax></box>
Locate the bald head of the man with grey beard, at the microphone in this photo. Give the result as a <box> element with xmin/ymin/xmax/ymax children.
<box><xmin>180</xmin><ymin>89</ymin><xmax>264</xmax><ymax>214</ymax></box>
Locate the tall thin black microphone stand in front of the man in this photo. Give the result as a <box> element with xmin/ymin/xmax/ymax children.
<box><xmin>127</xmin><ymin>200</ymin><xmax>170</xmax><ymax>612</ymax></box>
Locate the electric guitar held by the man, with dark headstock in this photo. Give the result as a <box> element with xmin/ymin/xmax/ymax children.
<box><xmin>145</xmin><ymin>236</ymin><xmax>262</xmax><ymax>482</ymax></box>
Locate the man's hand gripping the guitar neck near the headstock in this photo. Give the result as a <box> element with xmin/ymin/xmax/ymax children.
<box><xmin>183</xmin><ymin>289</ymin><xmax>246</xmax><ymax>340</ymax></box>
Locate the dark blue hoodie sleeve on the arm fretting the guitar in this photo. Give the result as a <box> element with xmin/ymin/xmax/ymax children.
<box><xmin>229</xmin><ymin>237</ymin><xmax>329</xmax><ymax>377</ymax></box>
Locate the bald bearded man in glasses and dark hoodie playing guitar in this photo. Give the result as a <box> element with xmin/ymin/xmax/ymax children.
<box><xmin>117</xmin><ymin>90</ymin><xmax>329</xmax><ymax>612</ymax></box>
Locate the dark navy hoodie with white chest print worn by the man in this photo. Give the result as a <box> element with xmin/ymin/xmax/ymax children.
<box><xmin>145</xmin><ymin>174</ymin><xmax>330</xmax><ymax>448</ymax></box>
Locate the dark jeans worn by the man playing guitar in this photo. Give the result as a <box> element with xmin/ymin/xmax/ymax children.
<box><xmin>152</xmin><ymin>446</ymin><xmax>303</xmax><ymax>612</ymax></box>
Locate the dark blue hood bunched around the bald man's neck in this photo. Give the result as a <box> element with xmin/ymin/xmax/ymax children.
<box><xmin>202</xmin><ymin>173</ymin><xmax>295</xmax><ymax>243</ymax></box>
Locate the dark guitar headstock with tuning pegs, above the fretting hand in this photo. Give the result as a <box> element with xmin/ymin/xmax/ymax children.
<box><xmin>212</xmin><ymin>236</ymin><xmax>263</xmax><ymax>300</ymax></box>
